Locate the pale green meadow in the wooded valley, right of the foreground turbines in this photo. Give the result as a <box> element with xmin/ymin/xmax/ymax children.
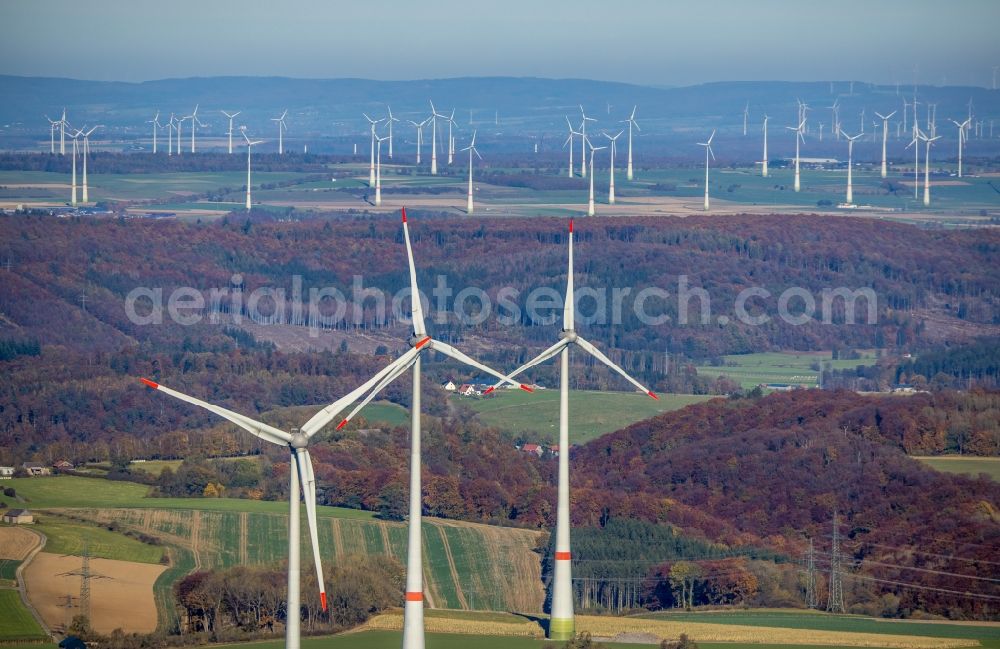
<box><xmin>698</xmin><ymin>352</ymin><xmax>876</xmax><ymax>389</ymax></box>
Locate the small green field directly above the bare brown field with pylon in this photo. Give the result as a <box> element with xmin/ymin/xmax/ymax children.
<box><xmin>34</xmin><ymin>514</ymin><xmax>165</xmax><ymax>563</ymax></box>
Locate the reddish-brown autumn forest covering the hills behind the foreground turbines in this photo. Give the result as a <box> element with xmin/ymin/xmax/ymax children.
<box><xmin>0</xmin><ymin>214</ymin><xmax>1000</xmax><ymax>616</ymax></box>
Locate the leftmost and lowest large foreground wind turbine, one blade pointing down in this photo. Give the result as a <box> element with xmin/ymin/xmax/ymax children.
<box><xmin>140</xmin><ymin>372</ymin><xmax>406</xmax><ymax>649</ymax></box>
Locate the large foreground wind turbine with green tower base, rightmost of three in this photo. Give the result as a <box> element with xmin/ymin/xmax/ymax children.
<box><xmin>487</xmin><ymin>220</ymin><xmax>659</xmax><ymax>640</ymax></box>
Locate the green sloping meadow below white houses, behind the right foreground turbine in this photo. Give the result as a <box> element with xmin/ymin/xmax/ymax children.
<box><xmin>464</xmin><ymin>389</ymin><xmax>711</xmax><ymax>444</ymax></box>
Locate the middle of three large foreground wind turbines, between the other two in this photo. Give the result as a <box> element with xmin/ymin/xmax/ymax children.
<box><xmin>337</xmin><ymin>208</ymin><xmax>531</xmax><ymax>649</ymax></box>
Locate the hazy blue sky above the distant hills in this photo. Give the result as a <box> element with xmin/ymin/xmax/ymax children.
<box><xmin>0</xmin><ymin>0</ymin><xmax>1000</xmax><ymax>85</ymax></box>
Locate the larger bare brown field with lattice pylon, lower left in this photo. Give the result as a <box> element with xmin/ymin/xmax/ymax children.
<box><xmin>24</xmin><ymin>552</ymin><xmax>166</xmax><ymax>633</ymax></box>
